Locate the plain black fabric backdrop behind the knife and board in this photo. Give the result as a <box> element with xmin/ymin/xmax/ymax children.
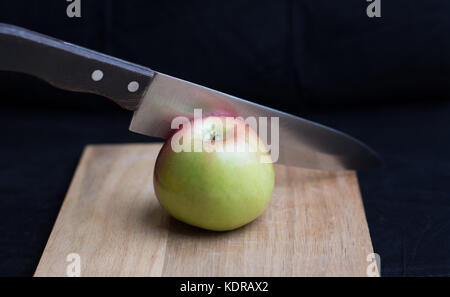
<box><xmin>0</xmin><ymin>0</ymin><xmax>450</xmax><ymax>276</ymax></box>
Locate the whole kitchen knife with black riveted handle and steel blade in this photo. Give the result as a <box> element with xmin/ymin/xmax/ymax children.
<box><xmin>0</xmin><ymin>24</ymin><xmax>380</xmax><ymax>170</ymax></box>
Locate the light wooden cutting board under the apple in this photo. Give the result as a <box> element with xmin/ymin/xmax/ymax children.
<box><xmin>35</xmin><ymin>144</ymin><xmax>373</xmax><ymax>276</ymax></box>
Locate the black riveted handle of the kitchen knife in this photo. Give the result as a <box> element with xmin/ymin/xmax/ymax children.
<box><xmin>0</xmin><ymin>23</ymin><xmax>154</xmax><ymax>110</ymax></box>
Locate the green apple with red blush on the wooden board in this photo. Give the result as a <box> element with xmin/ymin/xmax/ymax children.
<box><xmin>153</xmin><ymin>116</ymin><xmax>275</xmax><ymax>231</ymax></box>
